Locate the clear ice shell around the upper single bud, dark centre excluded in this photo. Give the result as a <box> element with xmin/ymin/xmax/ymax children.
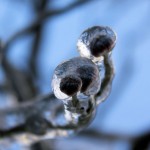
<box><xmin>77</xmin><ymin>26</ymin><xmax>116</xmax><ymax>63</ymax></box>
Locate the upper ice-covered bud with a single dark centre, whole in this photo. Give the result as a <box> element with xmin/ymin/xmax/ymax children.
<box><xmin>77</xmin><ymin>26</ymin><xmax>116</xmax><ymax>62</ymax></box>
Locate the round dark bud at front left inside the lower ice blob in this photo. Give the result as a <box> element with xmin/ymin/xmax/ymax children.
<box><xmin>60</xmin><ymin>75</ymin><xmax>82</xmax><ymax>96</ymax></box>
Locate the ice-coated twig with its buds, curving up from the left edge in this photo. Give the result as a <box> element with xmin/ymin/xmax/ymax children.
<box><xmin>0</xmin><ymin>27</ymin><xmax>116</xmax><ymax>148</ymax></box>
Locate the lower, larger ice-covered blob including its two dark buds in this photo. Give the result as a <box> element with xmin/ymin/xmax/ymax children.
<box><xmin>52</xmin><ymin>57</ymin><xmax>100</xmax><ymax>99</ymax></box>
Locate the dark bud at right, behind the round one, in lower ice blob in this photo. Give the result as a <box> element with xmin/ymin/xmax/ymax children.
<box><xmin>77</xmin><ymin>66</ymin><xmax>98</xmax><ymax>92</ymax></box>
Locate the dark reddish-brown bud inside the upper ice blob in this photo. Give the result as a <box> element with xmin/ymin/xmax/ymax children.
<box><xmin>90</xmin><ymin>36</ymin><xmax>113</xmax><ymax>57</ymax></box>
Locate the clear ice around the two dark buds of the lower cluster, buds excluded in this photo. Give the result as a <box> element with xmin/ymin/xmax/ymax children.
<box><xmin>52</xmin><ymin>57</ymin><xmax>100</xmax><ymax>99</ymax></box>
